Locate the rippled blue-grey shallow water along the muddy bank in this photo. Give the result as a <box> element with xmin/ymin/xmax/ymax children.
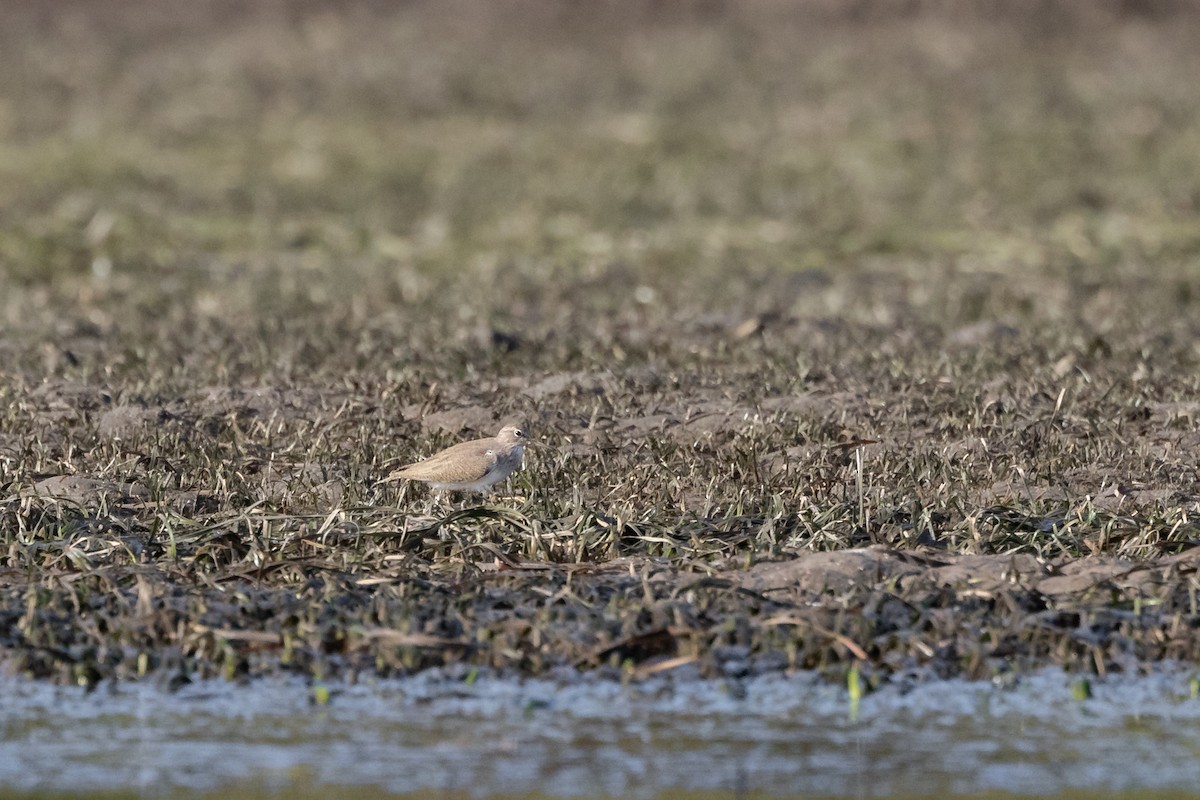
<box><xmin>0</xmin><ymin>670</ymin><xmax>1200</xmax><ymax>798</ymax></box>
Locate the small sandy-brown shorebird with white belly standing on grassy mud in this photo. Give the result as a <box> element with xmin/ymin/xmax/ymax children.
<box><xmin>385</xmin><ymin>425</ymin><xmax>527</xmax><ymax>494</ymax></box>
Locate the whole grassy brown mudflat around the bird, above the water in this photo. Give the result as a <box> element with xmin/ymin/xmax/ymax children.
<box><xmin>0</xmin><ymin>0</ymin><xmax>1200</xmax><ymax>684</ymax></box>
